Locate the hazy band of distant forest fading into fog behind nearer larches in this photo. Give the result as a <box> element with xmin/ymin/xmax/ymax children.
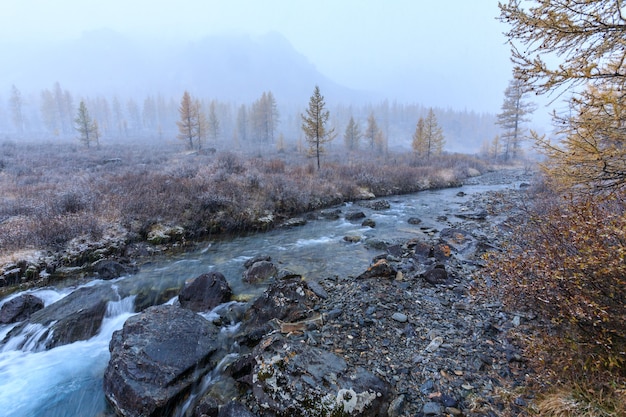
<box><xmin>0</xmin><ymin>83</ymin><xmax>499</xmax><ymax>154</ymax></box>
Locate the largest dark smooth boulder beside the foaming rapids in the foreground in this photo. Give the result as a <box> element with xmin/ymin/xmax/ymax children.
<box><xmin>104</xmin><ymin>305</ymin><xmax>220</xmax><ymax>417</ymax></box>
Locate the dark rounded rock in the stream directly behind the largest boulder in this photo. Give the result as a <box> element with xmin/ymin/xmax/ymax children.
<box><xmin>178</xmin><ymin>272</ymin><xmax>233</xmax><ymax>312</ymax></box>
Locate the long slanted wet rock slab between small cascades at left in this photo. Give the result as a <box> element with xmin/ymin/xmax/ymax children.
<box><xmin>5</xmin><ymin>286</ymin><xmax>119</xmax><ymax>349</ymax></box>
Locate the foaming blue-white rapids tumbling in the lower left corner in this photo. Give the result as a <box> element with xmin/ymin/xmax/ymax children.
<box><xmin>0</xmin><ymin>296</ymin><xmax>134</xmax><ymax>417</ymax></box>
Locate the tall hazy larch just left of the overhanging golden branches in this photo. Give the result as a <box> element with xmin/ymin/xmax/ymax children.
<box><xmin>496</xmin><ymin>76</ymin><xmax>536</xmax><ymax>161</ymax></box>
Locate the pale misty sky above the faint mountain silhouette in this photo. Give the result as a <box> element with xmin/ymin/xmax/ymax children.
<box><xmin>0</xmin><ymin>0</ymin><xmax>512</xmax><ymax>113</ymax></box>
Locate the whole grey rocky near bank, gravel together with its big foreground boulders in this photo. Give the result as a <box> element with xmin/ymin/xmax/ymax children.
<box><xmin>96</xmin><ymin>167</ymin><xmax>532</xmax><ymax>417</ymax></box>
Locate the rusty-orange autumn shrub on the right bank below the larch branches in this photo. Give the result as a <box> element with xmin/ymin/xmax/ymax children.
<box><xmin>487</xmin><ymin>189</ymin><xmax>626</xmax><ymax>383</ymax></box>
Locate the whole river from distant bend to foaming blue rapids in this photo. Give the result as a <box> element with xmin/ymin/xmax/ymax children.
<box><xmin>0</xmin><ymin>173</ymin><xmax>519</xmax><ymax>417</ymax></box>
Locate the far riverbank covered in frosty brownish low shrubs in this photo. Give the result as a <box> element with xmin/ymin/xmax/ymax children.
<box><xmin>0</xmin><ymin>144</ymin><xmax>488</xmax><ymax>295</ymax></box>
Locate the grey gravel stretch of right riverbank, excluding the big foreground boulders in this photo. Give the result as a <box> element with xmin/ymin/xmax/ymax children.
<box><xmin>229</xmin><ymin>167</ymin><xmax>534</xmax><ymax>416</ymax></box>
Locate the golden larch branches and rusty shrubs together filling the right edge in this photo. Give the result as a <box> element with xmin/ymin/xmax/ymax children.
<box><xmin>478</xmin><ymin>0</ymin><xmax>626</xmax><ymax>416</ymax></box>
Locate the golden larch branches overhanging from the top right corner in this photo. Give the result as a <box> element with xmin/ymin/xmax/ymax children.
<box><xmin>499</xmin><ymin>0</ymin><xmax>626</xmax><ymax>190</ymax></box>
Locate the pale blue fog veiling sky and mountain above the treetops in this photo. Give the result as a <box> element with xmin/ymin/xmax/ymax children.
<box><xmin>0</xmin><ymin>0</ymin><xmax>512</xmax><ymax>150</ymax></box>
